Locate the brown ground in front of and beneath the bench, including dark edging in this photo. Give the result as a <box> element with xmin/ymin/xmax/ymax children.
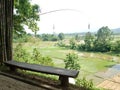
<box><xmin>0</xmin><ymin>72</ymin><xmax>80</xmax><ymax>90</ymax></box>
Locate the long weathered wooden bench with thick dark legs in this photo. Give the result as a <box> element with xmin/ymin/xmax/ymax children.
<box><xmin>4</xmin><ymin>61</ymin><xmax>79</xmax><ymax>86</ymax></box>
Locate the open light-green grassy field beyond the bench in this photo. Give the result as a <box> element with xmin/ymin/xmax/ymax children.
<box><xmin>14</xmin><ymin>41</ymin><xmax>120</xmax><ymax>84</ymax></box>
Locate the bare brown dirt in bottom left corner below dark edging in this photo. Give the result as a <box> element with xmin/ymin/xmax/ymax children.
<box><xmin>0</xmin><ymin>75</ymin><xmax>46</xmax><ymax>90</ymax></box>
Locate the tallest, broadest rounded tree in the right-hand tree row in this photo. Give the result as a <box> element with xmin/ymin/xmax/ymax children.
<box><xmin>94</xmin><ymin>26</ymin><xmax>112</xmax><ymax>52</ymax></box>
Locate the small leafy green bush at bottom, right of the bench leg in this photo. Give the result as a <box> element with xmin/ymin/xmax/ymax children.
<box><xmin>76</xmin><ymin>77</ymin><xmax>99</xmax><ymax>90</ymax></box>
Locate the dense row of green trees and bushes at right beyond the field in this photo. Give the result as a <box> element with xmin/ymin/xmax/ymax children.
<box><xmin>60</xmin><ymin>26</ymin><xmax>120</xmax><ymax>52</ymax></box>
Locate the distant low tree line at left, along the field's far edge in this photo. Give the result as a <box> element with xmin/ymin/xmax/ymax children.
<box><xmin>13</xmin><ymin>33</ymin><xmax>65</xmax><ymax>42</ymax></box>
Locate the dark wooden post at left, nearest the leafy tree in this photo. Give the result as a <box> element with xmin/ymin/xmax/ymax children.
<box><xmin>5</xmin><ymin>0</ymin><xmax>14</xmax><ymax>60</ymax></box>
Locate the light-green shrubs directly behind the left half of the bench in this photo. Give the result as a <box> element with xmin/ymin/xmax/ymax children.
<box><xmin>13</xmin><ymin>44</ymin><xmax>54</xmax><ymax>66</ymax></box>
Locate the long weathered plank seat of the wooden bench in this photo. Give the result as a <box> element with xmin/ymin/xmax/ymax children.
<box><xmin>4</xmin><ymin>61</ymin><xmax>79</xmax><ymax>78</ymax></box>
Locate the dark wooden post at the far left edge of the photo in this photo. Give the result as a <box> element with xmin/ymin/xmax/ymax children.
<box><xmin>0</xmin><ymin>0</ymin><xmax>6</xmax><ymax>63</ymax></box>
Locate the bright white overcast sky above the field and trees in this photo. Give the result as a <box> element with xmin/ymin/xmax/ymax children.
<box><xmin>27</xmin><ymin>0</ymin><xmax>120</xmax><ymax>33</ymax></box>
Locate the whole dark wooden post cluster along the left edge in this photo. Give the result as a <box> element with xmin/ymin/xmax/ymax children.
<box><xmin>0</xmin><ymin>0</ymin><xmax>14</xmax><ymax>63</ymax></box>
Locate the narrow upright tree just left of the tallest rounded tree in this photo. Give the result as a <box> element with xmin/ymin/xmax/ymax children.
<box><xmin>84</xmin><ymin>32</ymin><xmax>94</xmax><ymax>51</ymax></box>
